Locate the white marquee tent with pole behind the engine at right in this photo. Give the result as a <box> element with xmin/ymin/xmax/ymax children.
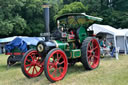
<box><xmin>89</xmin><ymin>24</ymin><xmax>128</xmax><ymax>59</ymax></box>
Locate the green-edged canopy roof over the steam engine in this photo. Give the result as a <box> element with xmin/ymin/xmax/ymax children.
<box><xmin>56</xmin><ymin>13</ymin><xmax>103</xmax><ymax>27</ymax></box>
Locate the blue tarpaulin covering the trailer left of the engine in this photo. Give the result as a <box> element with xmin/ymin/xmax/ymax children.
<box><xmin>5</xmin><ymin>37</ymin><xmax>45</xmax><ymax>52</ymax></box>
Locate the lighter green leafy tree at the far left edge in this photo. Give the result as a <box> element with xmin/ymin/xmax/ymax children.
<box><xmin>0</xmin><ymin>0</ymin><xmax>26</xmax><ymax>37</ymax></box>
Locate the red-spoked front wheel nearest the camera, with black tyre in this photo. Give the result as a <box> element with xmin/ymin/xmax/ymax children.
<box><xmin>44</xmin><ymin>48</ymin><xmax>68</xmax><ymax>82</ymax></box>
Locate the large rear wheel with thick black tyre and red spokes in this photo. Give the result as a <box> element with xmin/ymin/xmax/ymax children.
<box><xmin>81</xmin><ymin>37</ymin><xmax>100</xmax><ymax>70</ymax></box>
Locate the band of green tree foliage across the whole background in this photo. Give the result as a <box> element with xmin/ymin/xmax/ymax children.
<box><xmin>0</xmin><ymin>0</ymin><xmax>128</xmax><ymax>37</ymax></box>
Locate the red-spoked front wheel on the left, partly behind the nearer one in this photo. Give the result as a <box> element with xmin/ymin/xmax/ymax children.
<box><xmin>21</xmin><ymin>50</ymin><xmax>44</xmax><ymax>78</ymax></box>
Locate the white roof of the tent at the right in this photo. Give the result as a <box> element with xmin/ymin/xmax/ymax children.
<box><xmin>89</xmin><ymin>24</ymin><xmax>128</xmax><ymax>36</ymax></box>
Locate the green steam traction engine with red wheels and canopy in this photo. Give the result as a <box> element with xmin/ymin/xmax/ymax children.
<box><xmin>21</xmin><ymin>4</ymin><xmax>102</xmax><ymax>82</ymax></box>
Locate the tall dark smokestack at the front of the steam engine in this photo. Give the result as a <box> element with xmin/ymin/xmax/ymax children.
<box><xmin>43</xmin><ymin>3</ymin><xmax>50</xmax><ymax>41</ymax></box>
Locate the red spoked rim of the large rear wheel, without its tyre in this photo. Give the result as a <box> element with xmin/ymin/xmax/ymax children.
<box><xmin>87</xmin><ymin>39</ymin><xmax>100</xmax><ymax>69</ymax></box>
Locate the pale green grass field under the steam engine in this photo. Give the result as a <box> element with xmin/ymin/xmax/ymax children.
<box><xmin>0</xmin><ymin>55</ymin><xmax>128</xmax><ymax>85</ymax></box>
